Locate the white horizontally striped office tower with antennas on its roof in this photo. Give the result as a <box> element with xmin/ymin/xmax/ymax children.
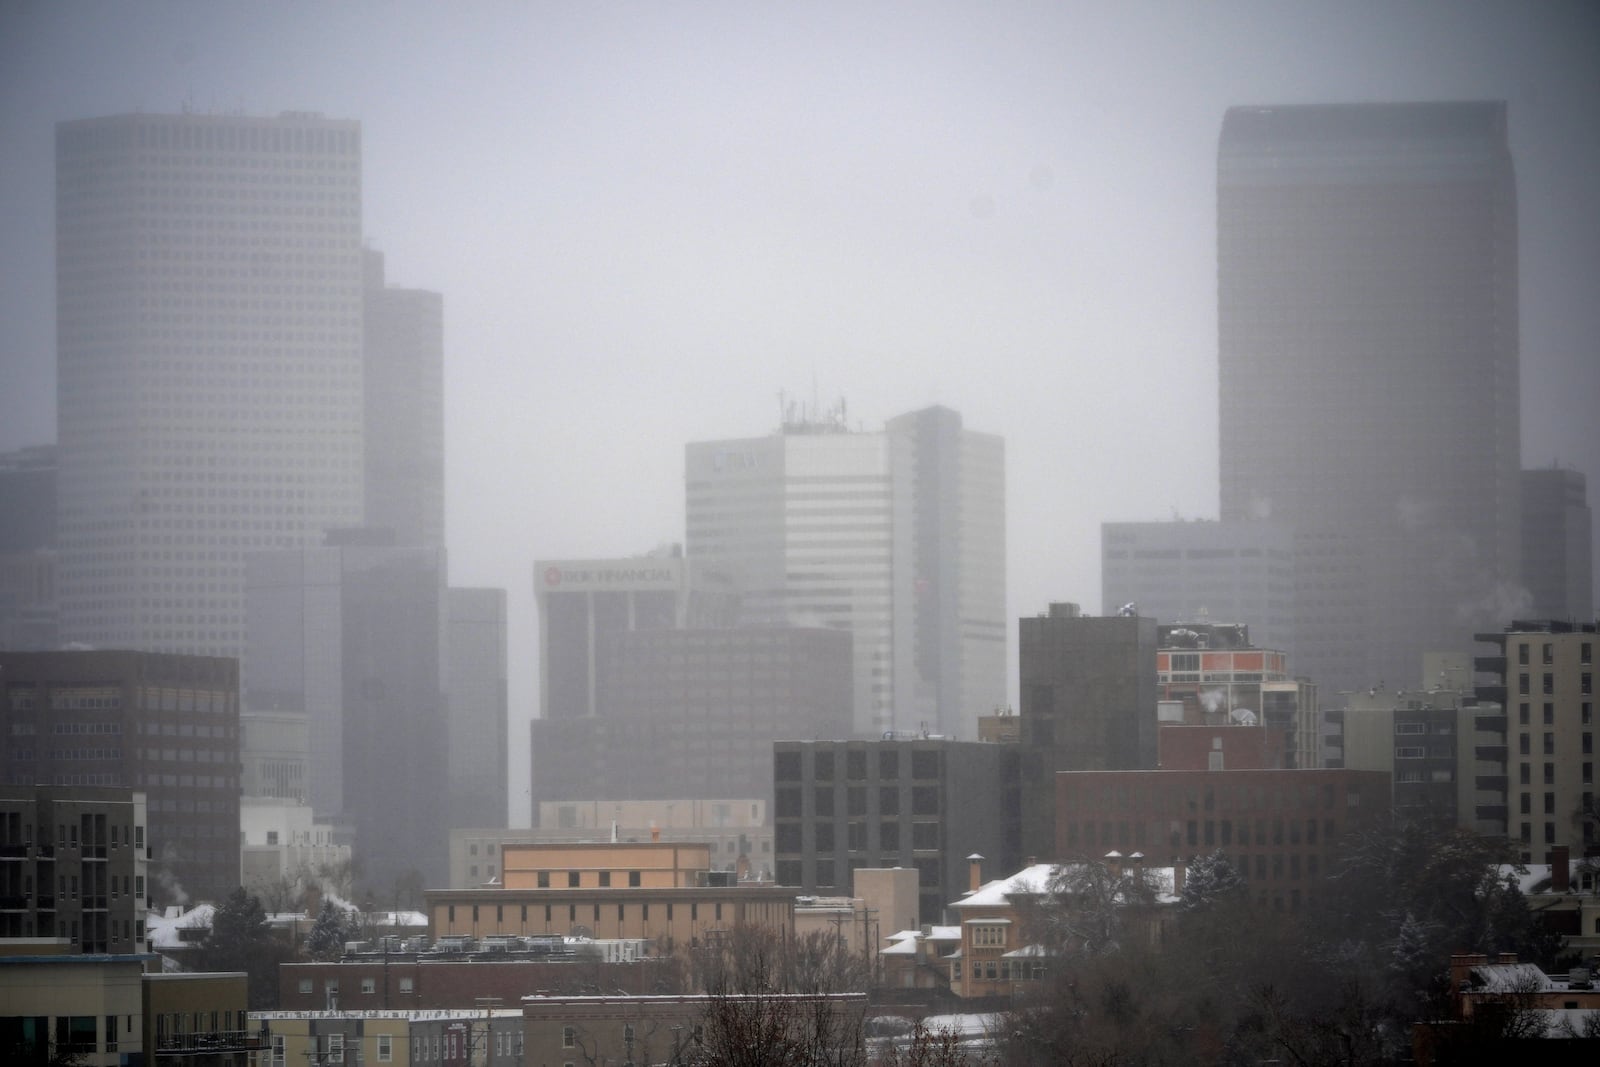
<box><xmin>685</xmin><ymin>408</ymin><xmax>1008</xmax><ymax>737</ymax></box>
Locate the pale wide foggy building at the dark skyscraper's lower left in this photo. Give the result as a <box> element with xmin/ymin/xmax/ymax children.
<box><xmin>1101</xmin><ymin>520</ymin><xmax>1294</xmax><ymax>661</ymax></box>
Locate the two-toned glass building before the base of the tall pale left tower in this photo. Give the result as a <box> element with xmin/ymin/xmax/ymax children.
<box><xmin>243</xmin><ymin>531</ymin><xmax>451</xmax><ymax>893</ymax></box>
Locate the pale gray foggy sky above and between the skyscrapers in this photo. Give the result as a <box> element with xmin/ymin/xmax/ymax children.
<box><xmin>0</xmin><ymin>0</ymin><xmax>1600</xmax><ymax>819</ymax></box>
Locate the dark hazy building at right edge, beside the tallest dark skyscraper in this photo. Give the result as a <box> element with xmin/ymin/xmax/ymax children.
<box><xmin>1522</xmin><ymin>467</ymin><xmax>1595</xmax><ymax>622</ymax></box>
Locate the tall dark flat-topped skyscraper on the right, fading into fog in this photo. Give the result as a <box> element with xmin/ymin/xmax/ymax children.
<box><xmin>1218</xmin><ymin>102</ymin><xmax>1523</xmax><ymax>693</ymax></box>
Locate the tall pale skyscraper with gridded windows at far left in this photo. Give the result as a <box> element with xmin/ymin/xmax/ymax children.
<box><xmin>56</xmin><ymin>114</ymin><xmax>365</xmax><ymax>657</ymax></box>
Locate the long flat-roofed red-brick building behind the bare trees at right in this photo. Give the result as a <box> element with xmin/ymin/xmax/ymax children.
<box><xmin>1056</xmin><ymin>769</ymin><xmax>1389</xmax><ymax>910</ymax></box>
